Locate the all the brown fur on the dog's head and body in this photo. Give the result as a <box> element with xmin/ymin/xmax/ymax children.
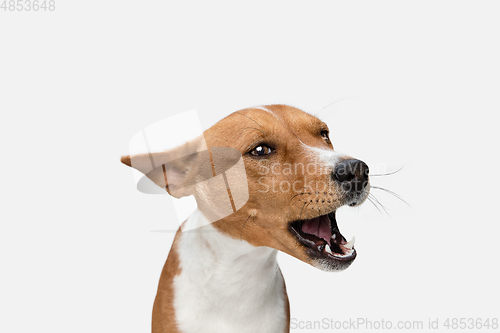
<box><xmin>122</xmin><ymin>105</ymin><xmax>356</xmax><ymax>333</ymax></box>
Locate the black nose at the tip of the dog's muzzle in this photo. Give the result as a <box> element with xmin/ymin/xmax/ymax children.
<box><xmin>332</xmin><ymin>159</ymin><xmax>370</xmax><ymax>192</ymax></box>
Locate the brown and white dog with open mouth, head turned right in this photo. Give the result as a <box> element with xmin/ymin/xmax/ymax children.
<box><xmin>121</xmin><ymin>105</ymin><xmax>370</xmax><ymax>333</ymax></box>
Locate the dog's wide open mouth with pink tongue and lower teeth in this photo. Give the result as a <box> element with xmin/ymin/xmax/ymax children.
<box><xmin>290</xmin><ymin>211</ymin><xmax>356</xmax><ymax>262</ymax></box>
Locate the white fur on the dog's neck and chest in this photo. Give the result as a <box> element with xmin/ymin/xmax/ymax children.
<box><xmin>174</xmin><ymin>210</ymin><xmax>287</xmax><ymax>333</ymax></box>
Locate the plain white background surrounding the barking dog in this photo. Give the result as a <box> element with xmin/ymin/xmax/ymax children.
<box><xmin>0</xmin><ymin>0</ymin><xmax>500</xmax><ymax>333</ymax></box>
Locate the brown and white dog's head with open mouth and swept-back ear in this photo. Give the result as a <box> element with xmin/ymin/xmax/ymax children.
<box><xmin>122</xmin><ymin>105</ymin><xmax>370</xmax><ymax>270</ymax></box>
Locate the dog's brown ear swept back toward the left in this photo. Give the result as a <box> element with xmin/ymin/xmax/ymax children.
<box><xmin>121</xmin><ymin>137</ymin><xmax>212</xmax><ymax>198</ymax></box>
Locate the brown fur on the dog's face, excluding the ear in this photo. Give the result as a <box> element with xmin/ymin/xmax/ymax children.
<box><xmin>204</xmin><ymin>105</ymin><xmax>340</xmax><ymax>263</ymax></box>
